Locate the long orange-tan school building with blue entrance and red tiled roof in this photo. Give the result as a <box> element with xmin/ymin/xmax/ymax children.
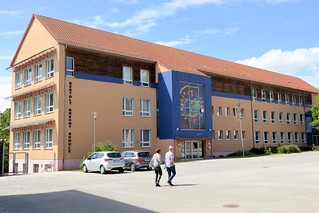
<box><xmin>6</xmin><ymin>15</ymin><xmax>317</xmax><ymax>172</ymax></box>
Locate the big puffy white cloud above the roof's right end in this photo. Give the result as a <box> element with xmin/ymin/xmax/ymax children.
<box><xmin>236</xmin><ymin>47</ymin><xmax>319</xmax><ymax>88</ymax></box>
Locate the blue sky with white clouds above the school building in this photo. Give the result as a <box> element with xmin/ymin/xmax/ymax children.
<box><xmin>0</xmin><ymin>0</ymin><xmax>319</xmax><ymax>112</ymax></box>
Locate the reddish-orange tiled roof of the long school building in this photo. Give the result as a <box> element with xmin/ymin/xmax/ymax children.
<box><xmin>11</xmin><ymin>15</ymin><xmax>318</xmax><ymax>93</ymax></box>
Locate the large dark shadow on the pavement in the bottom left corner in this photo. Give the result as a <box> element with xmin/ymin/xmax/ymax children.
<box><xmin>0</xmin><ymin>190</ymin><xmax>153</xmax><ymax>213</ymax></box>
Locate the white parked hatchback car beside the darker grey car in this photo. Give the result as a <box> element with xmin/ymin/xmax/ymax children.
<box><xmin>82</xmin><ymin>151</ymin><xmax>125</xmax><ymax>174</ymax></box>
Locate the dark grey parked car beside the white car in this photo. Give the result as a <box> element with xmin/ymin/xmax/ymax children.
<box><xmin>121</xmin><ymin>151</ymin><xmax>152</xmax><ymax>172</ymax></box>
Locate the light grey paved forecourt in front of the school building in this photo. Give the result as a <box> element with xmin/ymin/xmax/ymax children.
<box><xmin>0</xmin><ymin>152</ymin><xmax>319</xmax><ymax>213</ymax></box>
